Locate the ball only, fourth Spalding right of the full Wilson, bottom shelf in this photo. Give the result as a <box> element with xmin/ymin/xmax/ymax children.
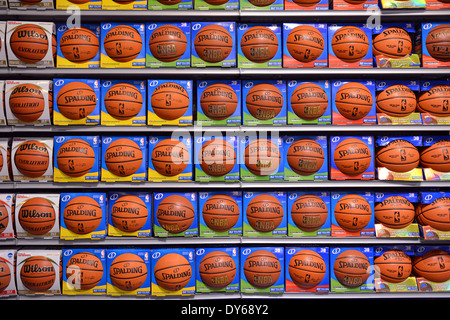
<box><xmin>198</xmin><ymin>251</ymin><xmax>236</xmax><ymax>290</ymax></box>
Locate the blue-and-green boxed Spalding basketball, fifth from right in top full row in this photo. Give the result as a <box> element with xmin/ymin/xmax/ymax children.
<box><xmin>237</xmin><ymin>23</ymin><xmax>283</xmax><ymax>68</ymax></box>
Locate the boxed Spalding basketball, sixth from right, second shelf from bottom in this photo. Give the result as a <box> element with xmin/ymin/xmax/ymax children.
<box><xmin>198</xmin><ymin>191</ymin><xmax>242</xmax><ymax>237</ymax></box>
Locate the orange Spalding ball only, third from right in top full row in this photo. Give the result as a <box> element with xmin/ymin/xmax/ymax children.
<box><xmin>331</xmin><ymin>26</ymin><xmax>370</xmax><ymax>63</ymax></box>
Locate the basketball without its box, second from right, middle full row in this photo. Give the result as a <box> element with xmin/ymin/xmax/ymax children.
<box><xmin>375</xmin><ymin>139</ymin><xmax>420</xmax><ymax>172</ymax></box>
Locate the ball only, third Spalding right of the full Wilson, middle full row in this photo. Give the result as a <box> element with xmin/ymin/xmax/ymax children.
<box><xmin>151</xmin><ymin>138</ymin><xmax>190</xmax><ymax>177</ymax></box>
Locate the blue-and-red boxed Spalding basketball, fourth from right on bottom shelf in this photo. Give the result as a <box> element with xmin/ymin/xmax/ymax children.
<box><xmin>285</xmin><ymin>247</ymin><xmax>330</xmax><ymax>293</ymax></box>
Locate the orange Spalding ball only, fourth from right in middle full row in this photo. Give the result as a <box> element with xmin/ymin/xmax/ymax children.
<box><xmin>286</xmin><ymin>139</ymin><xmax>325</xmax><ymax>176</ymax></box>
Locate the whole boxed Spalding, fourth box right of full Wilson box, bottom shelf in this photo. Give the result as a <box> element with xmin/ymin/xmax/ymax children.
<box><xmin>195</xmin><ymin>247</ymin><xmax>240</xmax><ymax>293</ymax></box>
